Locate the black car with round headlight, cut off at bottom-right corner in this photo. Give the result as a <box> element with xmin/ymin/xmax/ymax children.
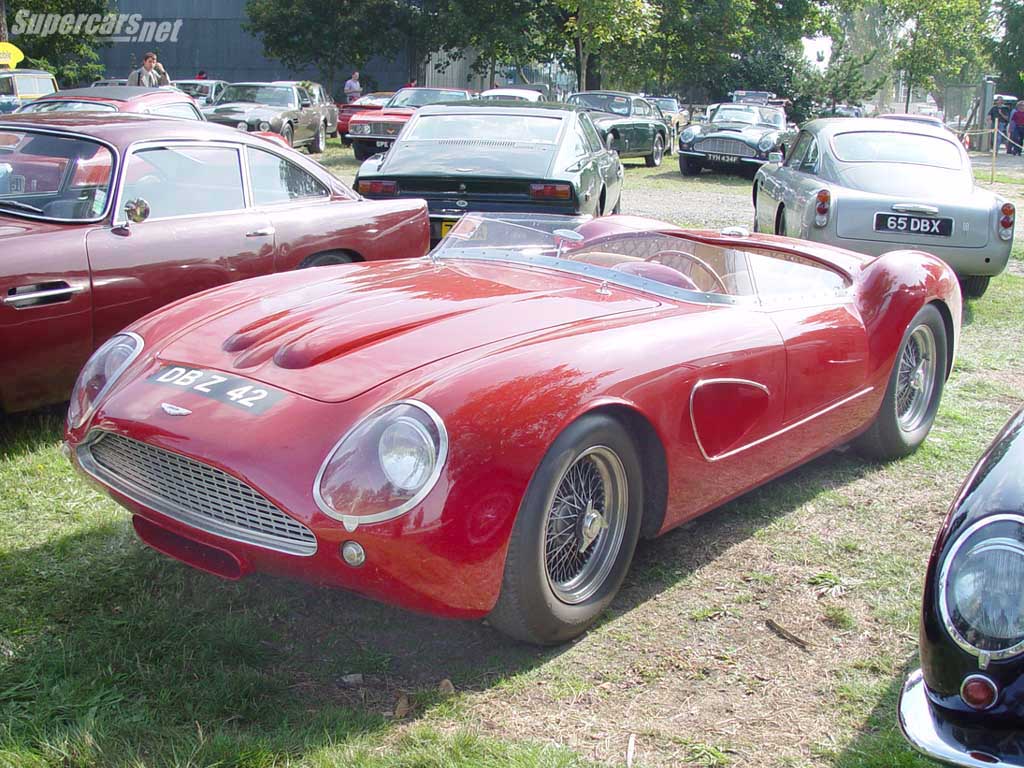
<box><xmin>899</xmin><ymin>409</ymin><xmax>1024</xmax><ymax>766</ymax></box>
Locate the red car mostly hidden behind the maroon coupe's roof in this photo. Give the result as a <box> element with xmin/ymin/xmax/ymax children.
<box><xmin>16</xmin><ymin>85</ymin><xmax>206</xmax><ymax>120</ymax></box>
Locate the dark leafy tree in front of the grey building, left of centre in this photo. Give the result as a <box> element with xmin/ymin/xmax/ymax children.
<box><xmin>246</xmin><ymin>0</ymin><xmax>410</xmax><ymax>93</ymax></box>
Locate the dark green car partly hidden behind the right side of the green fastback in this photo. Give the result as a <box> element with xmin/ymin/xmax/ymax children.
<box><xmin>565</xmin><ymin>91</ymin><xmax>672</xmax><ymax>168</ymax></box>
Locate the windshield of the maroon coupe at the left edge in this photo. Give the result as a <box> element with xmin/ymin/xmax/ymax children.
<box><xmin>0</xmin><ymin>128</ymin><xmax>114</xmax><ymax>221</ymax></box>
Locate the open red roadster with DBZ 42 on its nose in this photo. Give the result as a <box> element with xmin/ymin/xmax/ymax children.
<box><xmin>67</xmin><ymin>214</ymin><xmax>961</xmax><ymax>643</ymax></box>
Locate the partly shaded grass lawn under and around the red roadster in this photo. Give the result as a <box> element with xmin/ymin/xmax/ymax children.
<box><xmin>0</xmin><ymin>141</ymin><xmax>1024</xmax><ymax>768</ymax></box>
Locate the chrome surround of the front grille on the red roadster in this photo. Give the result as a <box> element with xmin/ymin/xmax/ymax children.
<box><xmin>75</xmin><ymin>430</ymin><xmax>318</xmax><ymax>557</ymax></box>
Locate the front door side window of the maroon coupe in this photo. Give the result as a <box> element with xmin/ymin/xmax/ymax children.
<box><xmin>122</xmin><ymin>145</ymin><xmax>246</xmax><ymax>220</ymax></box>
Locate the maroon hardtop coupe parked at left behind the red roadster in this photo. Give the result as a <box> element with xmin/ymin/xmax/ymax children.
<box><xmin>0</xmin><ymin>113</ymin><xmax>430</xmax><ymax>413</ymax></box>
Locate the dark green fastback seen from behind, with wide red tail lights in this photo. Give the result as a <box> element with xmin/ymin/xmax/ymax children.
<box><xmin>355</xmin><ymin>101</ymin><xmax>623</xmax><ymax>242</ymax></box>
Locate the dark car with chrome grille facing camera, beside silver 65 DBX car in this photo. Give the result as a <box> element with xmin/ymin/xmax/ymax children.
<box><xmin>679</xmin><ymin>102</ymin><xmax>791</xmax><ymax>176</ymax></box>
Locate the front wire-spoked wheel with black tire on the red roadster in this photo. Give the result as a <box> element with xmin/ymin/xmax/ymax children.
<box><xmin>489</xmin><ymin>414</ymin><xmax>643</xmax><ymax>645</ymax></box>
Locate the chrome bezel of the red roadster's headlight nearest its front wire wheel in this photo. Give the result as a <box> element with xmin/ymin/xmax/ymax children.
<box><xmin>313</xmin><ymin>399</ymin><xmax>449</xmax><ymax>531</ymax></box>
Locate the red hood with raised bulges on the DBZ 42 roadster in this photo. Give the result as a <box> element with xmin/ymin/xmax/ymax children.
<box><xmin>158</xmin><ymin>259</ymin><xmax>658</xmax><ymax>402</ymax></box>
